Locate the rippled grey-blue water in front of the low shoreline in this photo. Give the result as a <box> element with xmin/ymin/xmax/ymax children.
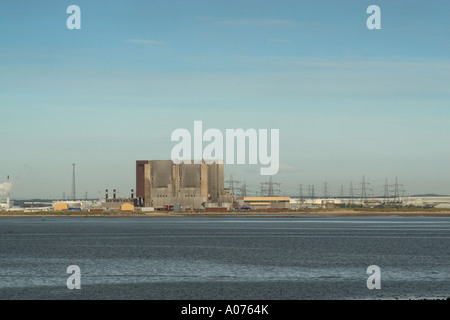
<box><xmin>0</xmin><ymin>217</ymin><xmax>450</xmax><ymax>300</ymax></box>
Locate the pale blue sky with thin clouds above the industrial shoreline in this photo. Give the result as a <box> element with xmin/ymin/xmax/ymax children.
<box><xmin>0</xmin><ymin>0</ymin><xmax>450</xmax><ymax>199</ymax></box>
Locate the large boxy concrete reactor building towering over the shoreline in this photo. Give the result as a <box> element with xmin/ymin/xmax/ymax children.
<box><xmin>136</xmin><ymin>160</ymin><xmax>229</xmax><ymax>209</ymax></box>
